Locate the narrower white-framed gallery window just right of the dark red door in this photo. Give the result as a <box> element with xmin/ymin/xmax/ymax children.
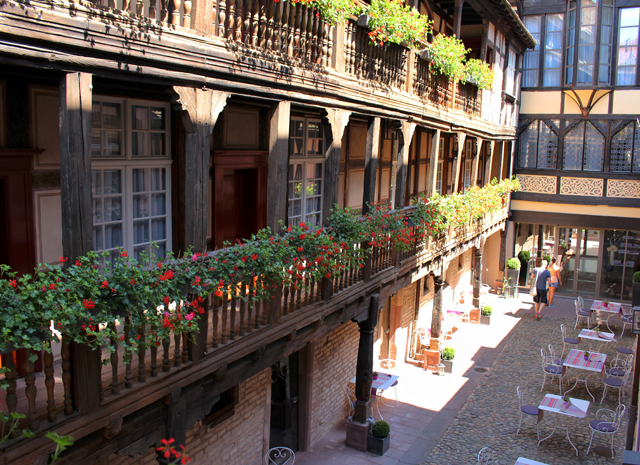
<box><xmin>288</xmin><ymin>118</ymin><xmax>324</xmax><ymax>226</ymax></box>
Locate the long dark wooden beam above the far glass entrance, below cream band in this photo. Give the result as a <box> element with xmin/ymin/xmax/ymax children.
<box><xmin>510</xmin><ymin>210</ymin><xmax>640</xmax><ymax>231</ymax></box>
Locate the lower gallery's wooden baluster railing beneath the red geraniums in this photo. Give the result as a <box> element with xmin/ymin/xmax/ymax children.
<box><xmin>0</xmin><ymin>206</ymin><xmax>507</xmax><ymax>463</ymax></box>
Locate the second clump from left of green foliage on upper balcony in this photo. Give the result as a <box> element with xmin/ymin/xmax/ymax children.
<box><xmin>365</xmin><ymin>0</ymin><xmax>431</xmax><ymax>47</ymax></box>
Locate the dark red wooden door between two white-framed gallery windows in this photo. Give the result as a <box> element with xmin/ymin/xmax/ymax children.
<box><xmin>211</xmin><ymin>151</ymin><xmax>268</xmax><ymax>248</ymax></box>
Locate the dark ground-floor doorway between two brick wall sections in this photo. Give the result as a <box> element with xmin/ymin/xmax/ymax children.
<box><xmin>269</xmin><ymin>352</ymin><xmax>300</xmax><ymax>451</ymax></box>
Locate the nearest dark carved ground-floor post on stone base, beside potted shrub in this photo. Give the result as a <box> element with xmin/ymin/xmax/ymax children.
<box><xmin>346</xmin><ymin>294</ymin><xmax>379</xmax><ymax>450</ymax></box>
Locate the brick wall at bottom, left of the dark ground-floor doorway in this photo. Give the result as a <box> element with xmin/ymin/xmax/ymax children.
<box><xmin>100</xmin><ymin>368</ymin><xmax>271</xmax><ymax>465</ymax></box>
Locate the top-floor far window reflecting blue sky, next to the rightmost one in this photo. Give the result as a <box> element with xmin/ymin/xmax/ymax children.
<box><xmin>565</xmin><ymin>0</ymin><xmax>613</xmax><ymax>85</ymax></box>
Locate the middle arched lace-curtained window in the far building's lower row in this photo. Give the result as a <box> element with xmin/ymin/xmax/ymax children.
<box><xmin>562</xmin><ymin>121</ymin><xmax>604</xmax><ymax>171</ymax></box>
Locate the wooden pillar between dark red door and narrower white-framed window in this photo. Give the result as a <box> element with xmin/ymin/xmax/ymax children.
<box><xmin>267</xmin><ymin>102</ymin><xmax>291</xmax><ymax>233</ymax></box>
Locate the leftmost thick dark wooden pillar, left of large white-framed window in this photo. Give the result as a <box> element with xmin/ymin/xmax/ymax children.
<box><xmin>59</xmin><ymin>73</ymin><xmax>102</xmax><ymax>413</ymax></box>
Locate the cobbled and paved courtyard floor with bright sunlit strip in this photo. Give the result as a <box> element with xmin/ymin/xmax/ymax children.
<box><xmin>296</xmin><ymin>292</ymin><xmax>635</xmax><ymax>465</ymax></box>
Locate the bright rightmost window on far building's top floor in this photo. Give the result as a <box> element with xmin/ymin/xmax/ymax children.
<box><xmin>616</xmin><ymin>8</ymin><xmax>640</xmax><ymax>86</ymax></box>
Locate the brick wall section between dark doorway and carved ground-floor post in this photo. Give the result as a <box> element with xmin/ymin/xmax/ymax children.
<box><xmin>311</xmin><ymin>322</ymin><xmax>360</xmax><ymax>446</ymax></box>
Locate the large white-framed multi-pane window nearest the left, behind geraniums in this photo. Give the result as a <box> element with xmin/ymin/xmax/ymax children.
<box><xmin>91</xmin><ymin>96</ymin><xmax>171</xmax><ymax>260</ymax></box>
